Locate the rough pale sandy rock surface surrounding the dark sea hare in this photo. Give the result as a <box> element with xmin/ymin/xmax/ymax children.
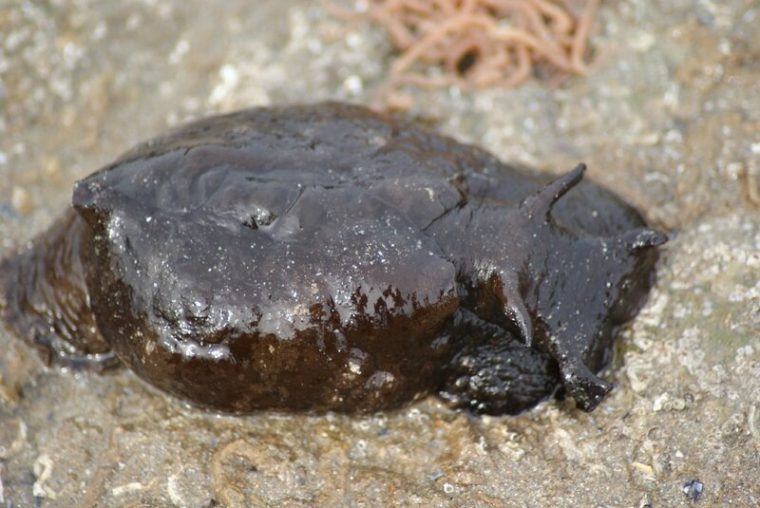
<box><xmin>0</xmin><ymin>0</ymin><xmax>760</xmax><ymax>507</ymax></box>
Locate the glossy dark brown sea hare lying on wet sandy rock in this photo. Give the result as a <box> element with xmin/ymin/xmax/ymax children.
<box><xmin>0</xmin><ymin>104</ymin><xmax>665</xmax><ymax>414</ymax></box>
